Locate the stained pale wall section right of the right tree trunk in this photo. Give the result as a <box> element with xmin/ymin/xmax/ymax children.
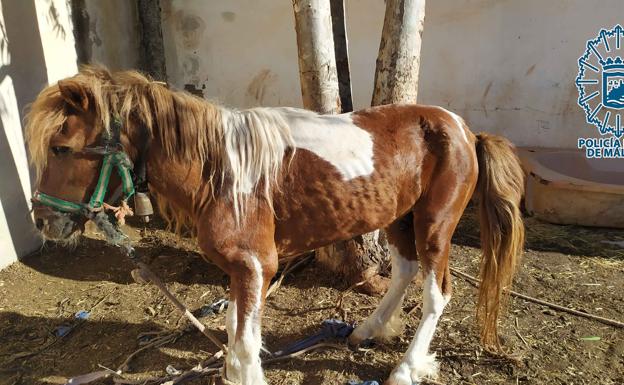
<box><xmin>419</xmin><ymin>0</ymin><xmax>624</xmax><ymax>148</ymax></box>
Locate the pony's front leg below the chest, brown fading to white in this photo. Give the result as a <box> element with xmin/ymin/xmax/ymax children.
<box><xmin>226</xmin><ymin>252</ymin><xmax>277</xmax><ymax>385</ymax></box>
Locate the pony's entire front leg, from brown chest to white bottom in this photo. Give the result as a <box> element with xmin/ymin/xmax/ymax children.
<box><xmin>197</xmin><ymin>199</ymin><xmax>278</xmax><ymax>385</ymax></box>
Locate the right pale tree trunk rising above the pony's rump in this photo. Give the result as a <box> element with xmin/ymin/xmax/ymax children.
<box><xmin>371</xmin><ymin>0</ymin><xmax>425</xmax><ymax>106</ymax></box>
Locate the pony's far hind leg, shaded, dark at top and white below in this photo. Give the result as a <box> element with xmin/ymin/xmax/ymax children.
<box><xmin>349</xmin><ymin>213</ymin><xmax>418</xmax><ymax>346</ymax></box>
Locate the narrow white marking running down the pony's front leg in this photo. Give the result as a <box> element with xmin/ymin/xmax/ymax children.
<box><xmin>234</xmin><ymin>255</ymin><xmax>266</xmax><ymax>385</ymax></box>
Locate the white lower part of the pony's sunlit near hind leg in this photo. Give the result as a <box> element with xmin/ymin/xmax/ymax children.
<box><xmin>389</xmin><ymin>272</ymin><xmax>450</xmax><ymax>384</ymax></box>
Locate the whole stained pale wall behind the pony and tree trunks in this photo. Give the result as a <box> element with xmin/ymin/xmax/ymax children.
<box><xmin>162</xmin><ymin>0</ymin><xmax>624</xmax><ymax>148</ymax></box>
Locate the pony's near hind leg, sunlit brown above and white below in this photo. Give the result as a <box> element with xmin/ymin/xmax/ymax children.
<box><xmin>386</xmin><ymin>170</ymin><xmax>472</xmax><ymax>385</ymax></box>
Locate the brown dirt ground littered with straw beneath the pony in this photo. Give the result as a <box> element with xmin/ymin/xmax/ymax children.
<box><xmin>0</xmin><ymin>210</ymin><xmax>624</xmax><ymax>385</ymax></box>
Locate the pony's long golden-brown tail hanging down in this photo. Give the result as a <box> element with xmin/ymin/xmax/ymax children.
<box><xmin>476</xmin><ymin>133</ymin><xmax>524</xmax><ymax>351</ymax></box>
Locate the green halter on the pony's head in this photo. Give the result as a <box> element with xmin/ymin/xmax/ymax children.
<box><xmin>32</xmin><ymin>118</ymin><xmax>134</xmax><ymax>217</ymax></box>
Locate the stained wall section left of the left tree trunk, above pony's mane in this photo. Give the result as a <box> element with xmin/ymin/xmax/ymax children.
<box><xmin>161</xmin><ymin>0</ymin><xmax>301</xmax><ymax>107</ymax></box>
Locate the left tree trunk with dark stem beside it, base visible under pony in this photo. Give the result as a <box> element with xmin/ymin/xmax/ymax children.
<box><xmin>293</xmin><ymin>0</ymin><xmax>387</xmax><ymax>294</ymax></box>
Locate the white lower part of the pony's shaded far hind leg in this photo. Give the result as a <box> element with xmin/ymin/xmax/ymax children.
<box><xmin>351</xmin><ymin>244</ymin><xmax>418</xmax><ymax>343</ymax></box>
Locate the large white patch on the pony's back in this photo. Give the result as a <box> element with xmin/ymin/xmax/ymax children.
<box><xmin>277</xmin><ymin>108</ymin><xmax>375</xmax><ymax>180</ymax></box>
